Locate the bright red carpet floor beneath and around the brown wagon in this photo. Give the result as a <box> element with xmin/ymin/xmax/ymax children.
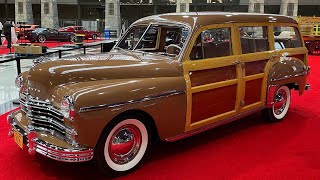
<box><xmin>0</xmin><ymin>56</ymin><xmax>320</xmax><ymax>180</ymax></box>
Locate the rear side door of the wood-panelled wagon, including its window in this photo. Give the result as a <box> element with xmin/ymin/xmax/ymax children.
<box><xmin>236</xmin><ymin>23</ymin><xmax>274</xmax><ymax>113</ymax></box>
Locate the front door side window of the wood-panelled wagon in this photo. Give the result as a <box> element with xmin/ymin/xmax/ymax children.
<box><xmin>189</xmin><ymin>28</ymin><xmax>232</xmax><ymax>60</ymax></box>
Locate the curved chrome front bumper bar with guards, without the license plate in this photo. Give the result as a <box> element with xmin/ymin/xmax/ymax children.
<box><xmin>7</xmin><ymin>114</ymin><xmax>93</xmax><ymax>162</ymax></box>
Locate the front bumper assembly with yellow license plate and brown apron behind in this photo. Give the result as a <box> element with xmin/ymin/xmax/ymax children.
<box><xmin>7</xmin><ymin>110</ymin><xmax>93</xmax><ymax>162</ymax></box>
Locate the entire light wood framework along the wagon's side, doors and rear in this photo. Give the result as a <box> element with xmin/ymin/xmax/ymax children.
<box><xmin>182</xmin><ymin>22</ymin><xmax>308</xmax><ymax>132</ymax></box>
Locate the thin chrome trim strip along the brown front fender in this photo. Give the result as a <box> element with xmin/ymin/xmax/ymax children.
<box><xmin>79</xmin><ymin>90</ymin><xmax>186</xmax><ymax>112</ymax></box>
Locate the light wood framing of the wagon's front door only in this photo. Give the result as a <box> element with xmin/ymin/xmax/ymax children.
<box><xmin>183</xmin><ymin>23</ymin><xmax>242</xmax><ymax>132</ymax></box>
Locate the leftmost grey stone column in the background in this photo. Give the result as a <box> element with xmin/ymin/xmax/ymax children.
<box><xmin>15</xmin><ymin>0</ymin><xmax>33</xmax><ymax>24</ymax></box>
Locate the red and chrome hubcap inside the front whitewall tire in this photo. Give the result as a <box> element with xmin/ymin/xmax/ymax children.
<box><xmin>109</xmin><ymin>124</ymin><xmax>142</xmax><ymax>164</ymax></box>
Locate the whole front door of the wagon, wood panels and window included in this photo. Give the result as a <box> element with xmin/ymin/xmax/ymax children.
<box><xmin>183</xmin><ymin>23</ymin><xmax>242</xmax><ymax>131</ymax></box>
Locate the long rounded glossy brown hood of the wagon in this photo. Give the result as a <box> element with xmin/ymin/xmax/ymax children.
<box><xmin>27</xmin><ymin>52</ymin><xmax>183</xmax><ymax>99</ymax></box>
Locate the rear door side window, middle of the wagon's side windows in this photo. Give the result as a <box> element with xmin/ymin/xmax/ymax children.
<box><xmin>239</xmin><ymin>26</ymin><xmax>270</xmax><ymax>54</ymax></box>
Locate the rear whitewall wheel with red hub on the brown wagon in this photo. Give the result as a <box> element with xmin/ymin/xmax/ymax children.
<box><xmin>263</xmin><ymin>86</ymin><xmax>291</xmax><ymax>122</ymax></box>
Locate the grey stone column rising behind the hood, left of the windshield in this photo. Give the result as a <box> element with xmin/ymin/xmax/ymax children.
<box><xmin>105</xmin><ymin>0</ymin><xmax>121</xmax><ymax>36</ymax></box>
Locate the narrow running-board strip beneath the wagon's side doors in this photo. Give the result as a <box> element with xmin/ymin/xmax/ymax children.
<box><xmin>165</xmin><ymin>106</ymin><xmax>265</xmax><ymax>142</ymax></box>
